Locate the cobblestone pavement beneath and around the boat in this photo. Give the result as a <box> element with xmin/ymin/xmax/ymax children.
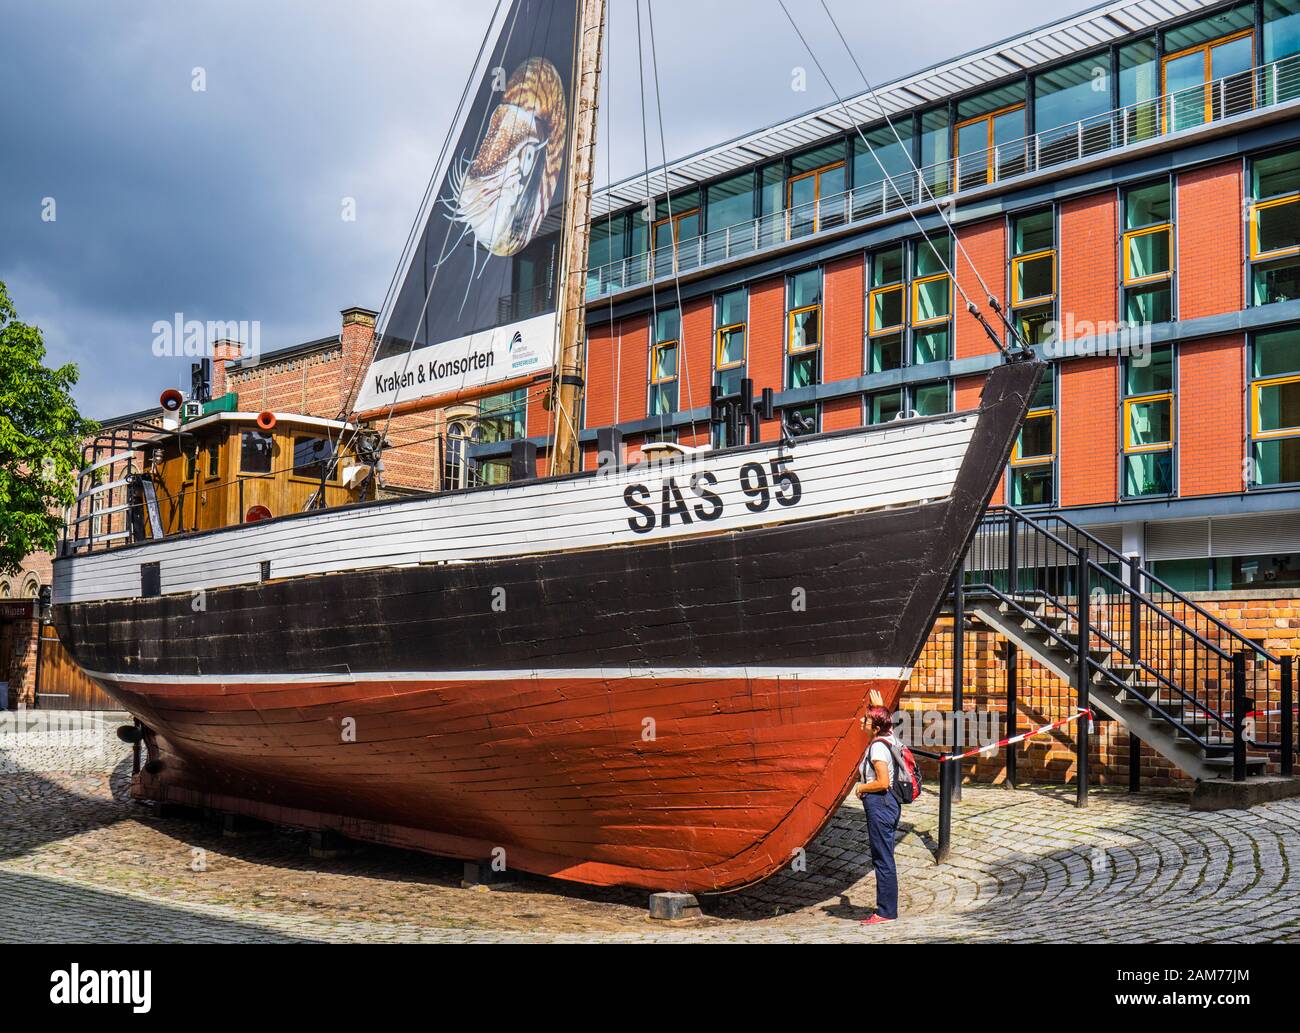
<box><xmin>0</xmin><ymin>720</ymin><xmax>1300</xmax><ymax>942</ymax></box>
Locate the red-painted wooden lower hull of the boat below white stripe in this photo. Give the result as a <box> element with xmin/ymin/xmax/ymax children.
<box><xmin>105</xmin><ymin>672</ymin><xmax>904</xmax><ymax>893</ymax></box>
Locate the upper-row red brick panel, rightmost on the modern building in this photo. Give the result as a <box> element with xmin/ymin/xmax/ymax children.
<box><xmin>1177</xmin><ymin>161</ymin><xmax>1245</xmax><ymax>320</ymax></box>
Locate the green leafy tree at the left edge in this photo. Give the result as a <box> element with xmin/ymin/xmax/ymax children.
<box><xmin>0</xmin><ymin>282</ymin><xmax>96</xmax><ymax>574</ymax></box>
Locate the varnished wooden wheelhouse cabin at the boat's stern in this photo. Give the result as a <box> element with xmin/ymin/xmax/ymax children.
<box><xmin>144</xmin><ymin>412</ymin><xmax>376</xmax><ymax>538</ymax></box>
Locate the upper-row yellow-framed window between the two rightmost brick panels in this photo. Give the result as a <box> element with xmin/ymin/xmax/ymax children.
<box><xmin>1121</xmin><ymin>179</ymin><xmax>1174</xmax><ymax>325</ymax></box>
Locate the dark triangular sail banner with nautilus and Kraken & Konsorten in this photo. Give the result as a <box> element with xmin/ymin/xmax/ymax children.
<box><xmin>358</xmin><ymin>0</ymin><xmax>577</xmax><ymax>412</ymax></box>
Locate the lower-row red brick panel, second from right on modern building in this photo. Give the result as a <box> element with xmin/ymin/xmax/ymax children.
<box><xmin>1058</xmin><ymin>357</ymin><xmax>1119</xmax><ymax>505</ymax></box>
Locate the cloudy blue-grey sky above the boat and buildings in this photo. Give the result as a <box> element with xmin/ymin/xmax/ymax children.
<box><xmin>0</xmin><ymin>0</ymin><xmax>1089</xmax><ymax>417</ymax></box>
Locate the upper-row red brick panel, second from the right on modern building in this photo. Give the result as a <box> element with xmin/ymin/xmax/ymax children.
<box><xmin>1057</xmin><ymin>191</ymin><xmax>1119</xmax><ymax>327</ymax></box>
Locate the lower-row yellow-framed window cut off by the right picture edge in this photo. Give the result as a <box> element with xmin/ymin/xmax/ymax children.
<box><xmin>1251</xmin><ymin>327</ymin><xmax>1300</xmax><ymax>487</ymax></box>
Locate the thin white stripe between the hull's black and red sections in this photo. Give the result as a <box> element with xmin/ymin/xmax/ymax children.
<box><xmin>86</xmin><ymin>667</ymin><xmax>911</xmax><ymax>685</ymax></box>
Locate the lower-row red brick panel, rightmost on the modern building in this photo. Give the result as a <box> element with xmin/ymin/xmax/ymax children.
<box><xmin>1178</xmin><ymin>335</ymin><xmax>1247</xmax><ymax>495</ymax></box>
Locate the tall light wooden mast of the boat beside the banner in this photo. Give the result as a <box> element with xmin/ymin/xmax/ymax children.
<box><xmin>550</xmin><ymin>0</ymin><xmax>606</xmax><ymax>474</ymax></box>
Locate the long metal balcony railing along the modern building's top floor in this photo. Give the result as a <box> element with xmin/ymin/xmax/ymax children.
<box><xmin>586</xmin><ymin>55</ymin><xmax>1300</xmax><ymax>300</ymax></box>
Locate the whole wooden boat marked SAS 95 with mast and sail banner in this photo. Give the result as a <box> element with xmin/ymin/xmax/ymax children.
<box><xmin>53</xmin><ymin>0</ymin><xmax>1043</xmax><ymax>893</ymax></box>
